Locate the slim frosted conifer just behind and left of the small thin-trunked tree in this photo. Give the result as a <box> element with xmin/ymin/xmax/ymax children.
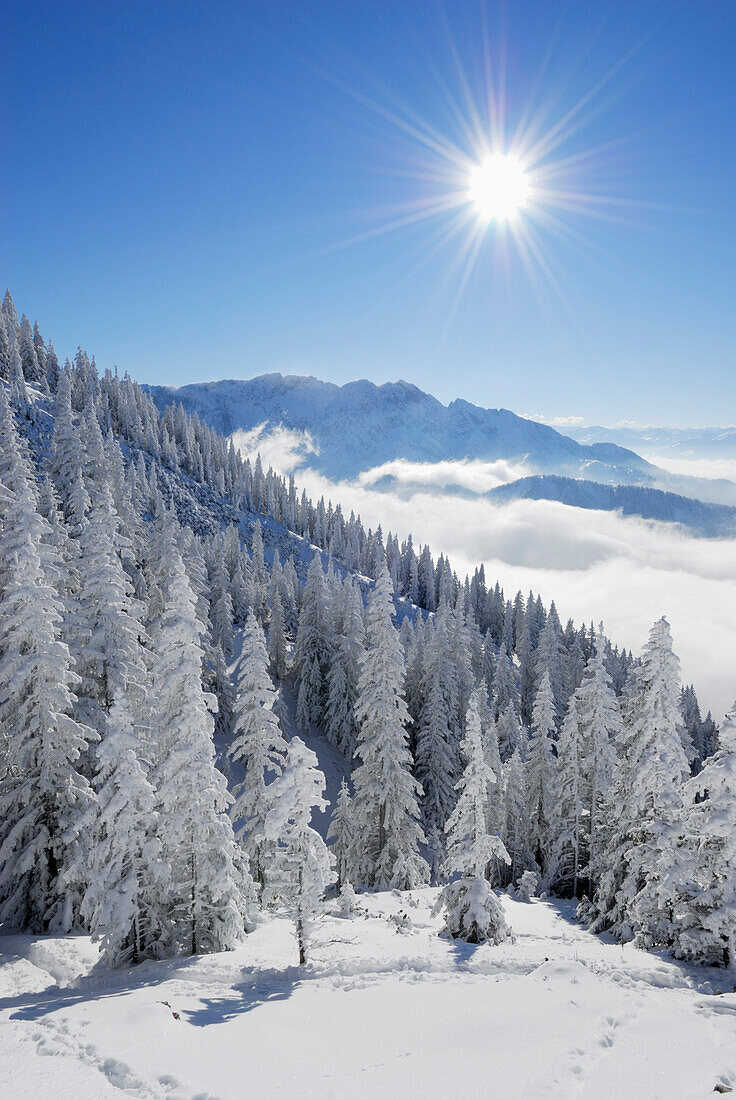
<box><xmin>228</xmin><ymin>611</ymin><xmax>286</xmax><ymax>887</ymax></box>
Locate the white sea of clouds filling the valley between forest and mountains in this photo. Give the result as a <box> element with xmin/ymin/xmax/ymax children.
<box><xmin>235</xmin><ymin>429</ymin><xmax>736</xmax><ymax>721</ymax></box>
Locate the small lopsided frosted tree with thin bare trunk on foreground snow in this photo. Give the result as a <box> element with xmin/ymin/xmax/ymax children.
<box><xmin>266</xmin><ymin>737</ymin><xmax>336</xmax><ymax>965</ymax></box>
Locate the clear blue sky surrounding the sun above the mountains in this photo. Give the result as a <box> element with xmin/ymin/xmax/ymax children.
<box><xmin>0</xmin><ymin>0</ymin><xmax>736</xmax><ymax>425</ymax></box>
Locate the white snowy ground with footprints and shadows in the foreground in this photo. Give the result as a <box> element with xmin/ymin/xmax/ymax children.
<box><xmin>0</xmin><ymin>890</ymin><xmax>736</xmax><ymax>1100</ymax></box>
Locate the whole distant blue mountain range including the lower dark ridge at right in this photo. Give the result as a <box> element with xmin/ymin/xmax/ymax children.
<box><xmin>146</xmin><ymin>374</ymin><xmax>736</xmax><ymax>536</ymax></box>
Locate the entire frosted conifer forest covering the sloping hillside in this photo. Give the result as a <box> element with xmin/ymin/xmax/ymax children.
<box><xmin>0</xmin><ymin>293</ymin><xmax>736</xmax><ymax>967</ymax></box>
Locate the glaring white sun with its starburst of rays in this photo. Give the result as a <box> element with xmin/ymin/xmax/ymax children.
<box><xmin>290</xmin><ymin>12</ymin><xmax>663</xmax><ymax>317</ymax></box>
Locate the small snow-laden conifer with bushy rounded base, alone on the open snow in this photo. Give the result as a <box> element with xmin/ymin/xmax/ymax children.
<box><xmin>441</xmin><ymin>694</ymin><xmax>510</xmax><ymax>944</ymax></box>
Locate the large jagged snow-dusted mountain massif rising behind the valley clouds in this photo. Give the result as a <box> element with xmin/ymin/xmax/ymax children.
<box><xmin>149</xmin><ymin>374</ymin><xmax>653</xmax><ymax>483</ymax></box>
